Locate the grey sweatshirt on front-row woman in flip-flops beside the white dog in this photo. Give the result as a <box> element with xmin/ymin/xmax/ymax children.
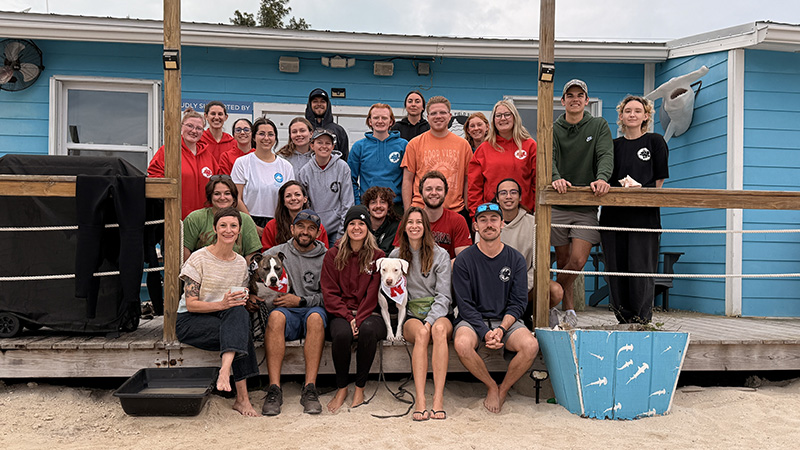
<box><xmin>389</xmin><ymin>245</ymin><xmax>452</xmax><ymax>326</ymax></box>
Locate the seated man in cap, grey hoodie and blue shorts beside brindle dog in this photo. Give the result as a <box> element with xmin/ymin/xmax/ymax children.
<box><xmin>250</xmin><ymin>209</ymin><xmax>327</xmax><ymax>416</ymax></box>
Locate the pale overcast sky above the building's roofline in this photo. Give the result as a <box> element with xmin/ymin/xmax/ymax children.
<box><xmin>0</xmin><ymin>0</ymin><xmax>800</xmax><ymax>42</ymax></box>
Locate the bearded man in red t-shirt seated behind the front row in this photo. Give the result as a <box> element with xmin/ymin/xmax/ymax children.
<box><xmin>393</xmin><ymin>170</ymin><xmax>472</xmax><ymax>260</ymax></box>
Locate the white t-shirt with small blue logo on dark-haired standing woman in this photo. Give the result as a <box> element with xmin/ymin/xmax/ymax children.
<box><xmin>231</xmin><ymin>152</ymin><xmax>294</xmax><ymax>217</ymax></box>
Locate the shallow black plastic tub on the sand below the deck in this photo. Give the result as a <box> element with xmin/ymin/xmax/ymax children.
<box><xmin>114</xmin><ymin>367</ymin><xmax>219</xmax><ymax>416</ymax></box>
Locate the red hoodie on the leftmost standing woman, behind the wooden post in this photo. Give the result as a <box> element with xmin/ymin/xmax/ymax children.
<box><xmin>147</xmin><ymin>139</ymin><xmax>218</xmax><ymax>219</ymax></box>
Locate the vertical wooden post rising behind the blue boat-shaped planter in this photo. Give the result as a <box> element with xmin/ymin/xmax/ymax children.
<box><xmin>534</xmin><ymin>0</ymin><xmax>556</xmax><ymax>327</ymax></box>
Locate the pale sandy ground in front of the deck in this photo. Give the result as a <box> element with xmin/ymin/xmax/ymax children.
<box><xmin>0</xmin><ymin>379</ymin><xmax>800</xmax><ymax>449</ymax></box>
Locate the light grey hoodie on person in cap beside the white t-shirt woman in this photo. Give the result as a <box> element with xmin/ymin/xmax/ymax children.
<box><xmin>297</xmin><ymin>155</ymin><xmax>354</xmax><ymax>245</ymax></box>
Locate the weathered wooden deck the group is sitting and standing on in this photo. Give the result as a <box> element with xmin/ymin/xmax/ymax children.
<box><xmin>0</xmin><ymin>308</ymin><xmax>800</xmax><ymax>378</ymax></box>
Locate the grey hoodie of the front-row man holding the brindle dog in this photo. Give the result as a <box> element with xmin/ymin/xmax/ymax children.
<box><xmin>265</xmin><ymin>238</ymin><xmax>327</xmax><ymax>307</ymax></box>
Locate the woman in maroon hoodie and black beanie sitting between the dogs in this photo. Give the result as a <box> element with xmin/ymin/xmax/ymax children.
<box><xmin>320</xmin><ymin>205</ymin><xmax>386</xmax><ymax>412</ymax></box>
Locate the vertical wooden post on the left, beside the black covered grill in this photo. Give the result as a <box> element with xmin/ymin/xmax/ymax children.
<box><xmin>163</xmin><ymin>0</ymin><xmax>183</xmax><ymax>343</ymax></box>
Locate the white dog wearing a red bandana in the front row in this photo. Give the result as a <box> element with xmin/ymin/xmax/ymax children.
<box><xmin>375</xmin><ymin>258</ymin><xmax>408</xmax><ymax>341</ymax></box>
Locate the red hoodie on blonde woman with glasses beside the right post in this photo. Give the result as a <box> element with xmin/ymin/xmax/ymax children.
<box><xmin>467</xmin><ymin>136</ymin><xmax>536</xmax><ymax>216</ymax></box>
